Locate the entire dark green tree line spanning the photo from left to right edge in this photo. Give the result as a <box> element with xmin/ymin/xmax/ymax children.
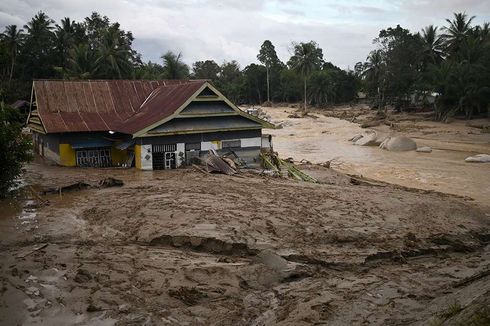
<box><xmin>0</xmin><ymin>12</ymin><xmax>490</xmax><ymax>120</ymax></box>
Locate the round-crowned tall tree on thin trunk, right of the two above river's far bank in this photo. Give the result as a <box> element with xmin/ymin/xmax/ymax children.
<box><xmin>288</xmin><ymin>41</ymin><xmax>323</xmax><ymax>112</ymax></box>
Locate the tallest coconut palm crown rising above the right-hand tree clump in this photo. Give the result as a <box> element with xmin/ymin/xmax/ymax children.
<box><xmin>443</xmin><ymin>13</ymin><xmax>475</xmax><ymax>54</ymax></box>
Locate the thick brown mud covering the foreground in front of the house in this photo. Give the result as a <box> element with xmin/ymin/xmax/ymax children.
<box><xmin>0</xmin><ymin>163</ymin><xmax>490</xmax><ymax>325</ymax></box>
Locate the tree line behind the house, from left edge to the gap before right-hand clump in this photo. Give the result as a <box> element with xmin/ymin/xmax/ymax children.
<box><xmin>0</xmin><ymin>12</ymin><xmax>358</xmax><ymax>106</ymax></box>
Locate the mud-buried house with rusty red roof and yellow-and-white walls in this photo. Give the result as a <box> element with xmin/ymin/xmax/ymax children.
<box><xmin>28</xmin><ymin>80</ymin><xmax>273</xmax><ymax>170</ymax></box>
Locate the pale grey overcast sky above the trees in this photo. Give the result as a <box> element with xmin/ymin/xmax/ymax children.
<box><xmin>0</xmin><ymin>0</ymin><xmax>490</xmax><ymax>69</ymax></box>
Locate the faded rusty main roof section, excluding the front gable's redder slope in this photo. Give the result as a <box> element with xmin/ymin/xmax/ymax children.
<box><xmin>33</xmin><ymin>80</ymin><xmax>204</xmax><ymax>133</ymax></box>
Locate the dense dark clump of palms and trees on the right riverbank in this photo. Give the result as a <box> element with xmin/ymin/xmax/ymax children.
<box><xmin>355</xmin><ymin>13</ymin><xmax>490</xmax><ymax>120</ymax></box>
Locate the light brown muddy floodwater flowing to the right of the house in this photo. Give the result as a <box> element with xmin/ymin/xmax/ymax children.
<box><xmin>264</xmin><ymin>108</ymin><xmax>490</xmax><ymax>204</ymax></box>
